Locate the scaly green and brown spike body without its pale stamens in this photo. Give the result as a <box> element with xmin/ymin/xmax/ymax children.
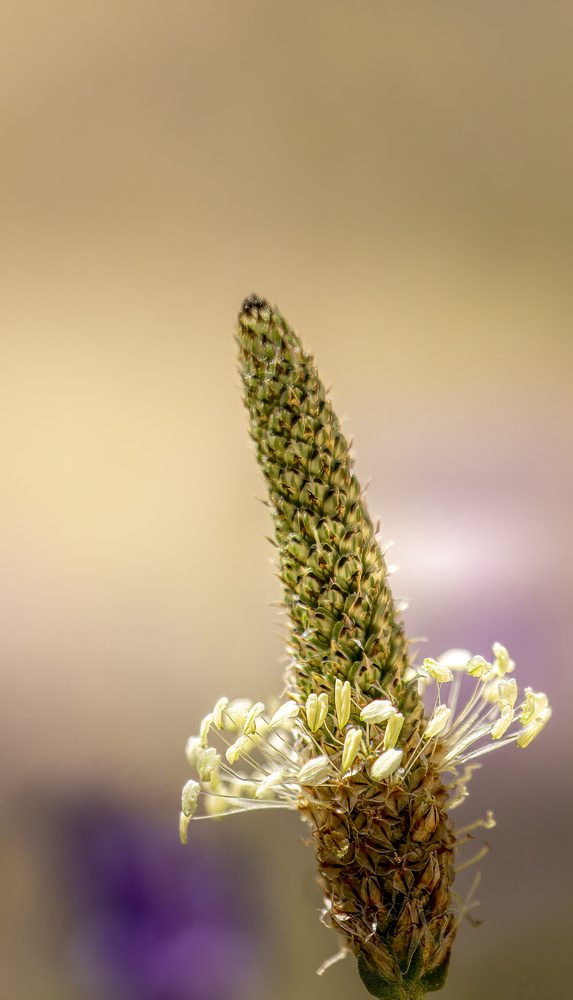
<box><xmin>237</xmin><ymin>295</ymin><xmax>459</xmax><ymax>1000</ymax></box>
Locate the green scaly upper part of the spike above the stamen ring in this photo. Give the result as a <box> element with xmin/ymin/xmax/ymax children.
<box><xmin>238</xmin><ymin>296</ymin><xmax>408</xmax><ymax>693</ymax></box>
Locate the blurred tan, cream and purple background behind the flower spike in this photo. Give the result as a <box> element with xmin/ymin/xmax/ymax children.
<box><xmin>0</xmin><ymin>0</ymin><xmax>573</xmax><ymax>1000</ymax></box>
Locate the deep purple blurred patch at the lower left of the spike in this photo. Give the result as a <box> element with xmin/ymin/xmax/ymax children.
<box><xmin>62</xmin><ymin>805</ymin><xmax>265</xmax><ymax>1000</ymax></box>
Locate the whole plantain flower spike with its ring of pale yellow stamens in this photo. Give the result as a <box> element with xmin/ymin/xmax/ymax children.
<box><xmin>181</xmin><ymin>295</ymin><xmax>551</xmax><ymax>1000</ymax></box>
